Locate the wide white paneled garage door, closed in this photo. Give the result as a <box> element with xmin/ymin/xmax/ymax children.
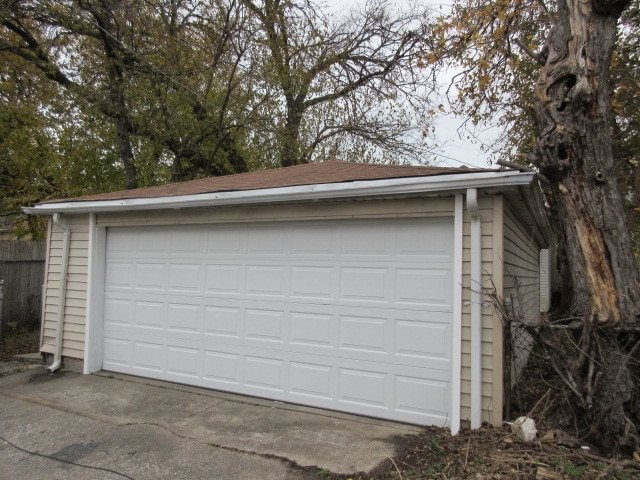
<box><xmin>103</xmin><ymin>218</ymin><xmax>454</xmax><ymax>425</ymax></box>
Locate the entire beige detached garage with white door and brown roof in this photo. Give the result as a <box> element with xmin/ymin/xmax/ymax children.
<box><xmin>24</xmin><ymin>161</ymin><xmax>552</xmax><ymax>434</ymax></box>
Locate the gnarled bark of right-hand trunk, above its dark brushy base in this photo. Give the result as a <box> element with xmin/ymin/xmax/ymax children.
<box><xmin>532</xmin><ymin>0</ymin><xmax>640</xmax><ymax>325</ymax></box>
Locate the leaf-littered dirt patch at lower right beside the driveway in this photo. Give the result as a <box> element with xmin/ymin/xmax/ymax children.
<box><xmin>316</xmin><ymin>427</ymin><xmax>640</xmax><ymax>480</ymax></box>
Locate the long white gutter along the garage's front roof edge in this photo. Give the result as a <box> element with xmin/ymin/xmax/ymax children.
<box><xmin>22</xmin><ymin>170</ymin><xmax>535</xmax><ymax>215</ymax></box>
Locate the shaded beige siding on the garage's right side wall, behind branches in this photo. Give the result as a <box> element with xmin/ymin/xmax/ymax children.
<box><xmin>504</xmin><ymin>205</ymin><xmax>540</xmax><ymax>383</ymax></box>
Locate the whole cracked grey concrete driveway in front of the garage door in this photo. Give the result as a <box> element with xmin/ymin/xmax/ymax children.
<box><xmin>0</xmin><ymin>366</ymin><xmax>420</xmax><ymax>480</ymax></box>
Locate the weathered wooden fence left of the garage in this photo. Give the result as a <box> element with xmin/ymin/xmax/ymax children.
<box><xmin>0</xmin><ymin>240</ymin><xmax>45</xmax><ymax>333</ymax></box>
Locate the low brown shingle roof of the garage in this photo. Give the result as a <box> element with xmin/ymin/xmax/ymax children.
<box><xmin>42</xmin><ymin>160</ymin><xmax>492</xmax><ymax>204</ymax></box>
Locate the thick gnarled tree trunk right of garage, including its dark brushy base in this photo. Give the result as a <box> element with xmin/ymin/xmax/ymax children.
<box><xmin>532</xmin><ymin>0</ymin><xmax>640</xmax><ymax>452</ymax></box>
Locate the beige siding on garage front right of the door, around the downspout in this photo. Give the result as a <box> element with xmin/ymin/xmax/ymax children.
<box><xmin>460</xmin><ymin>196</ymin><xmax>502</xmax><ymax>425</ymax></box>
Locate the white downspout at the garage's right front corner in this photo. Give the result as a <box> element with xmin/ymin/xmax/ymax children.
<box><xmin>467</xmin><ymin>188</ymin><xmax>482</xmax><ymax>428</ymax></box>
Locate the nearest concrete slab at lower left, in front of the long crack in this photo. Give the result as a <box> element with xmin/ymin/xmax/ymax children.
<box><xmin>0</xmin><ymin>397</ymin><xmax>303</xmax><ymax>480</ymax></box>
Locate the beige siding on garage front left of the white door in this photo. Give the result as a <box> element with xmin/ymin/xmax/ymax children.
<box><xmin>41</xmin><ymin>215</ymin><xmax>89</xmax><ymax>359</ymax></box>
